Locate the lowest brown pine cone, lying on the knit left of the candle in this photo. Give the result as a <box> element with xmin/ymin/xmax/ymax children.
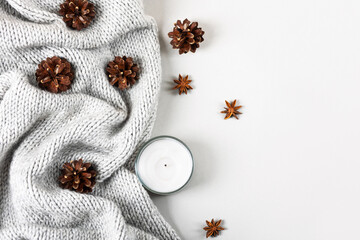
<box><xmin>59</xmin><ymin>159</ymin><xmax>96</xmax><ymax>193</ymax></box>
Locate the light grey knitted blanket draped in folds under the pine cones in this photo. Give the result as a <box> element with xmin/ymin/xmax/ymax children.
<box><xmin>0</xmin><ymin>0</ymin><xmax>179</xmax><ymax>240</ymax></box>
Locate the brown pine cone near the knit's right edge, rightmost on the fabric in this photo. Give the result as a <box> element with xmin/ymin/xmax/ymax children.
<box><xmin>106</xmin><ymin>56</ymin><xmax>140</xmax><ymax>90</ymax></box>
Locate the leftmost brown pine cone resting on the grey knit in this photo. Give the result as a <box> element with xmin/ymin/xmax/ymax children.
<box><xmin>35</xmin><ymin>56</ymin><xmax>74</xmax><ymax>93</ymax></box>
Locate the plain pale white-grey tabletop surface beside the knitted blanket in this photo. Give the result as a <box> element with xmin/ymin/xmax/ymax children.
<box><xmin>145</xmin><ymin>0</ymin><xmax>360</xmax><ymax>240</ymax></box>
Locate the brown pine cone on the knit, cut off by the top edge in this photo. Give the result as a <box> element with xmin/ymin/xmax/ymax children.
<box><xmin>59</xmin><ymin>0</ymin><xmax>95</xmax><ymax>31</ymax></box>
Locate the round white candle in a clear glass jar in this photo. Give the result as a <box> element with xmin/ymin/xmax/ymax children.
<box><xmin>135</xmin><ymin>136</ymin><xmax>194</xmax><ymax>194</ymax></box>
